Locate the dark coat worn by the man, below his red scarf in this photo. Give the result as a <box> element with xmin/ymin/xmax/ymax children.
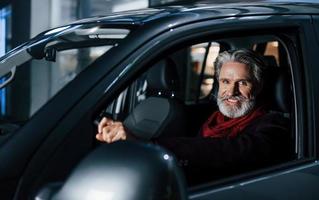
<box><xmin>156</xmin><ymin>113</ymin><xmax>293</xmax><ymax>184</ymax></box>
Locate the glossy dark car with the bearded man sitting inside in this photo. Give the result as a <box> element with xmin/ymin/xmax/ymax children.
<box><xmin>0</xmin><ymin>1</ymin><xmax>319</xmax><ymax>200</ymax></box>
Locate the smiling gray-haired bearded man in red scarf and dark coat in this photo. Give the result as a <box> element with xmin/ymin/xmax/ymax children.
<box><xmin>96</xmin><ymin>49</ymin><xmax>292</xmax><ymax>184</ymax></box>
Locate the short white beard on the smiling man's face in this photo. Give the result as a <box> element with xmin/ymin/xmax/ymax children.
<box><xmin>217</xmin><ymin>96</ymin><xmax>256</xmax><ymax>118</ymax></box>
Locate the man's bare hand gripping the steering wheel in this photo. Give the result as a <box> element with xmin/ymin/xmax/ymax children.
<box><xmin>95</xmin><ymin>117</ymin><xmax>127</xmax><ymax>143</ymax></box>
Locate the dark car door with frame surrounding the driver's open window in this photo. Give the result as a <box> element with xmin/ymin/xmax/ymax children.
<box><xmin>1</xmin><ymin>9</ymin><xmax>317</xmax><ymax>199</ymax></box>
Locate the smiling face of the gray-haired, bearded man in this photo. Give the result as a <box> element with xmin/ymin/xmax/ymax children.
<box><xmin>217</xmin><ymin>62</ymin><xmax>255</xmax><ymax>118</ymax></box>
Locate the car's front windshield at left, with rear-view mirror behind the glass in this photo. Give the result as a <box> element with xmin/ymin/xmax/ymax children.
<box><xmin>0</xmin><ymin>24</ymin><xmax>130</xmax><ymax>130</ymax></box>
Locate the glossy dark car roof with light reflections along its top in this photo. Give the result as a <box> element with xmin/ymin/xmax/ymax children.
<box><xmin>0</xmin><ymin>0</ymin><xmax>319</xmax><ymax>67</ymax></box>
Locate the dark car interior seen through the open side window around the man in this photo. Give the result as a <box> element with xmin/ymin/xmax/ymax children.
<box><xmin>96</xmin><ymin>35</ymin><xmax>297</xmax><ymax>185</ymax></box>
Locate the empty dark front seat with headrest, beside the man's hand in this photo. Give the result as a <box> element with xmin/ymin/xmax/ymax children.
<box><xmin>123</xmin><ymin>58</ymin><xmax>185</xmax><ymax>140</ymax></box>
